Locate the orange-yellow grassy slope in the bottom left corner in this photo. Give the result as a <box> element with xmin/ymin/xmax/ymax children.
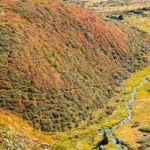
<box><xmin>0</xmin><ymin>110</ymin><xmax>54</xmax><ymax>150</ymax></box>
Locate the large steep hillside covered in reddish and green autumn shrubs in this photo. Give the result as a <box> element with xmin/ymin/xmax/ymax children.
<box><xmin>0</xmin><ymin>0</ymin><xmax>149</xmax><ymax>131</ymax></box>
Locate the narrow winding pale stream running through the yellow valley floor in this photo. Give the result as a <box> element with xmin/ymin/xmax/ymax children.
<box><xmin>96</xmin><ymin>74</ymin><xmax>150</xmax><ymax>150</ymax></box>
